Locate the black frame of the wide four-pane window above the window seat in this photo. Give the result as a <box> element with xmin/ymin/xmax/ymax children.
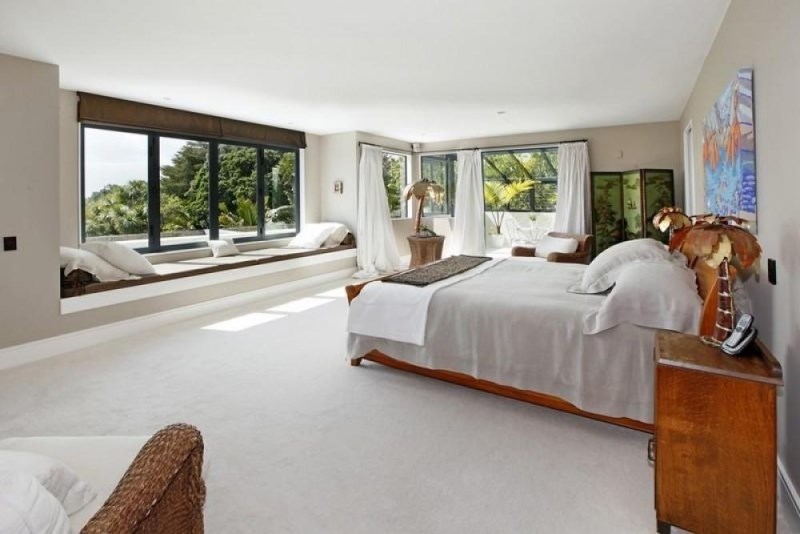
<box><xmin>79</xmin><ymin>122</ymin><xmax>301</xmax><ymax>253</ymax></box>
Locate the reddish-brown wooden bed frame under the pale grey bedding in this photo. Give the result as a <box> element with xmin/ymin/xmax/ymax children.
<box><xmin>345</xmin><ymin>258</ymin><xmax>717</xmax><ymax>434</ymax></box>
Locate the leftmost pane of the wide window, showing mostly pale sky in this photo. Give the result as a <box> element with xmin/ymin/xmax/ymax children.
<box><xmin>82</xmin><ymin>129</ymin><xmax>149</xmax><ymax>248</ymax></box>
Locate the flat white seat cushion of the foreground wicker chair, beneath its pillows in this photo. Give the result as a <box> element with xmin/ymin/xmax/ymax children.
<box><xmin>0</xmin><ymin>436</ymin><xmax>208</xmax><ymax>532</ymax></box>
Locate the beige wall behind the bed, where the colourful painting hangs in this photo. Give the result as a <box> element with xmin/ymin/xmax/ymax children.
<box><xmin>681</xmin><ymin>0</ymin><xmax>800</xmax><ymax>487</ymax></box>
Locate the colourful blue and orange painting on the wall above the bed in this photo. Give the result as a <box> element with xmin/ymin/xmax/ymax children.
<box><xmin>703</xmin><ymin>68</ymin><xmax>756</xmax><ymax>232</ymax></box>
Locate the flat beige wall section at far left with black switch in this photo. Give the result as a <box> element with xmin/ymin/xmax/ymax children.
<box><xmin>0</xmin><ymin>55</ymin><xmax>60</xmax><ymax>347</ymax></box>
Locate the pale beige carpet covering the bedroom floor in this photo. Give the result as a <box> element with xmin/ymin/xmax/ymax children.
<box><xmin>0</xmin><ymin>286</ymin><xmax>791</xmax><ymax>534</ymax></box>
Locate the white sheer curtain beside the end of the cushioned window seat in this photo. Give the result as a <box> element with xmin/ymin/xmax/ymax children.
<box><xmin>354</xmin><ymin>145</ymin><xmax>400</xmax><ymax>278</ymax></box>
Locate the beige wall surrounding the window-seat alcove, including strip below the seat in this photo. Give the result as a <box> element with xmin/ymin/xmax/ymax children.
<box><xmin>0</xmin><ymin>65</ymin><xmax>355</xmax><ymax>349</ymax></box>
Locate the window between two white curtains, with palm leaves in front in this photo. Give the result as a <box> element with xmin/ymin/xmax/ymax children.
<box><xmin>482</xmin><ymin>147</ymin><xmax>558</xmax><ymax>214</ymax></box>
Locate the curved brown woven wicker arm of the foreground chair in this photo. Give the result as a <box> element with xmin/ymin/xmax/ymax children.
<box><xmin>81</xmin><ymin>424</ymin><xmax>206</xmax><ymax>534</ymax></box>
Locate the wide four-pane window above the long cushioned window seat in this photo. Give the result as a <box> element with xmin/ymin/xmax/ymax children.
<box><xmin>81</xmin><ymin>125</ymin><xmax>300</xmax><ymax>252</ymax></box>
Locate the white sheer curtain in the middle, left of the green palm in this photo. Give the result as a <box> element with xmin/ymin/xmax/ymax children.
<box><xmin>447</xmin><ymin>150</ymin><xmax>486</xmax><ymax>256</ymax></box>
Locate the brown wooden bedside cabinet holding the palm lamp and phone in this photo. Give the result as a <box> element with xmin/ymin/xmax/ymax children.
<box><xmin>650</xmin><ymin>332</ymin><xmax>782</xmax><ymax>534</ymax></box>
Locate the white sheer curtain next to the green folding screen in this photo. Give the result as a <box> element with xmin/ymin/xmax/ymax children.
<box><xmin>553</xmin><ymin>142</ymin><xmax>589</xmax><ymax>234</ymax></box>
